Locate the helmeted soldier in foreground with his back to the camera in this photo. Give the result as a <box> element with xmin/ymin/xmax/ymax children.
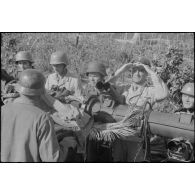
<box><xmin>1</xmin><ymin>69</ymin><xmax>76</xmax><ymax>162</ymax></box>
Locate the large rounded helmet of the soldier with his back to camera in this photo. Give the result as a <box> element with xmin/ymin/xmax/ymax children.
<box><xmin>16</xmin><ymin>69</ymin><xmax>45</xmax><ymax>96</ymax></box>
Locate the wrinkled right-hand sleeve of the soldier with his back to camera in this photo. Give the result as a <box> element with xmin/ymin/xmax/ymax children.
<box><xmin>37</xmin><ymin>114</ymin><xmax>67</xmax><ymax>162</ymax></box>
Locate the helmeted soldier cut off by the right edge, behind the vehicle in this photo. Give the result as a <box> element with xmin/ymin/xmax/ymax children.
<box><xmin>175</xmin><ymin>83</ymin><xmax>194</xmax><ymax>114</ymax></box>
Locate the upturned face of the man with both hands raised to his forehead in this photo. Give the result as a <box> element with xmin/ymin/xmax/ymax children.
<box><xmin>132</xmin><ymin>66</ymin><xmax>147</xmax><ymax>84</ymax></box>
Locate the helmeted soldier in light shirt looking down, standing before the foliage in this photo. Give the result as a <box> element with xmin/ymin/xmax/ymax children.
<box><xmin>45</xmin><ymin>51</ymin><xmax>81</xmax><ymax>98</ymax></box>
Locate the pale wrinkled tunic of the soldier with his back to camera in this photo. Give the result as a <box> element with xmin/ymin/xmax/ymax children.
<box><xmin>1</xmin><ymin>98</ymin><xmax>66</xmax><ymax>162</ymax></box>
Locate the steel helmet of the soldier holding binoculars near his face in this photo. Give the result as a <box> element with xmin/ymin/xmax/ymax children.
<box><xmin>86</xmin><ymin>62</ymin><xmax>107</xmax><ymax>77</ymax></box>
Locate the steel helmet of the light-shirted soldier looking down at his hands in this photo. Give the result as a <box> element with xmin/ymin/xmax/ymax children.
<box><xmin>50</xmin><ymin>51</ymin><xmax>69</xmax><ymax>65</ymax></box>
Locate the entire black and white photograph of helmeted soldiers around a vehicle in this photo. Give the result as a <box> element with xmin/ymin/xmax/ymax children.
<box><xmin>1</xmin><ymin>32</ymin><xmax>195</xmax><ymax>163</ymax></box>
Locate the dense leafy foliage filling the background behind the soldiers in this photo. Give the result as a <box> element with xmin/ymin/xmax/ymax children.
<box><xmin>1</xmin><ymin>33</ymin><xmax>194</xmax><ymax>112</ymax></box>
